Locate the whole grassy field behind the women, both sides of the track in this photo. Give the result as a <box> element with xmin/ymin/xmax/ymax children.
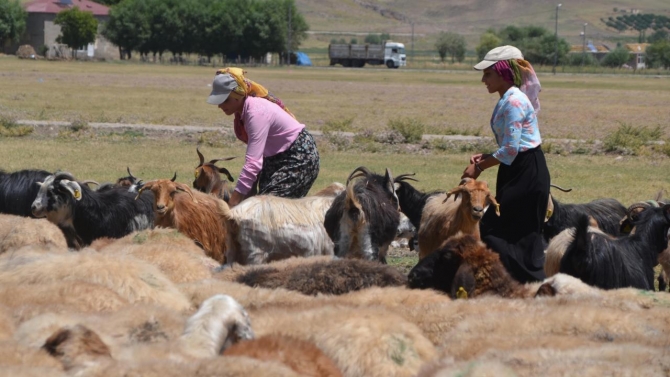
<box><xmin>0</xmin><ymin>57</ymin><xmax>670</xmax><ymax>204</ymax></box>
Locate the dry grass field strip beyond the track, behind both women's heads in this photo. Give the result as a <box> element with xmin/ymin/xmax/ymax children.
<box><xmin>0</xmin><ymin>57</ymin><xmax>670</xmax><ymax>140</ymax></box>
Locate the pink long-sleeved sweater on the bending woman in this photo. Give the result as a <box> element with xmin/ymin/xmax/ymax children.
<box><xmin>235</xmin><ymin>97</ymin><xmax>305</xmax><ymax>195</ymax></box>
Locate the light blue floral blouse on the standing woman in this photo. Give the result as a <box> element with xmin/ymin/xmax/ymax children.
<box><xmin>491</xmin><ymin>86</ymin><xmax>542</xmax><ymax>165</ymax></box>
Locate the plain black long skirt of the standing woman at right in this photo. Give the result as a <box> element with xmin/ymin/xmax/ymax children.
<box><xmin>480</xmin><ymin>146</ymin><xmax>550</xmax><ymax>283</ymax></box>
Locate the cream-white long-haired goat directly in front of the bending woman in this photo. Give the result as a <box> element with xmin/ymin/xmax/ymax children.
<box><xmin>219</xmin><ymin>191</ymin><xmax>334</xmax><ymax>265</ymax></box>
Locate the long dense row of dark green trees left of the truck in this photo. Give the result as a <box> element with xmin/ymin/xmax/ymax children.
<box><xmin>102</xmin><ymin>0</ymin><xmax>308</xmax><ymax>60</ymax></box>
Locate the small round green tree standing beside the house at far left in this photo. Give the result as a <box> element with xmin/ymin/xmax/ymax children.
<box><xmin>54</xmin><ymin>7</ymin><xmax>98</xmax><ymax>58</ymax></box>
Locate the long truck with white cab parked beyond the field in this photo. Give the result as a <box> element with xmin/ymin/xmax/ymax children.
<box><xmin>328</xmin><ymin>41</ymin><xmax>407</xmax><ymax>68</ymax></box>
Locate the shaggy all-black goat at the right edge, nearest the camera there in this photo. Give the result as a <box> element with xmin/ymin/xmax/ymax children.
<box><xmin>560</xmin><ymin>204</ymin><xmax>670</xmax><ymax>290</ymax></box>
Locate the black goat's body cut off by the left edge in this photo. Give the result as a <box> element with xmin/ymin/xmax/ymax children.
<box><xmin>0</xmin><ymin>170</ymin><xmax>51</xmax><ymax>217</ymax></box>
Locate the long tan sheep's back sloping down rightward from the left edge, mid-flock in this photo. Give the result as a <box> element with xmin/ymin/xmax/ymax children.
<box><xmin>0</xmin><ymin>249</ymin><xmax>190</xmax><ymax>310</ymax></box>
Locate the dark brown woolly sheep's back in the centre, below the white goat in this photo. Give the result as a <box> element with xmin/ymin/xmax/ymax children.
<box><xmin>231</xmin><ymin>258</ymin><xmax>407</xmax><ymax>296</ymax></box>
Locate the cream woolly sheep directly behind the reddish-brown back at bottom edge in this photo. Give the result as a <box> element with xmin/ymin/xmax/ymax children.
<box><xmin>249</xmin><ymin>305</ymin><xmax>436</xmax><ymax>377</ymax></box>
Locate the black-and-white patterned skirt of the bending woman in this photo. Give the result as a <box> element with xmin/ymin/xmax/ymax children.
<box><xmin>258</xmin><ymin>129</ymin><xmax>319</xmax><ymax>198</ymax></box>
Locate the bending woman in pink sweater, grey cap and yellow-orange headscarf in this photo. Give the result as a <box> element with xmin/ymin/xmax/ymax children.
<box><xmin>207</xmin><ymin>68</ymin><xmax>319</xmax><ymax>207</ymax></box>
